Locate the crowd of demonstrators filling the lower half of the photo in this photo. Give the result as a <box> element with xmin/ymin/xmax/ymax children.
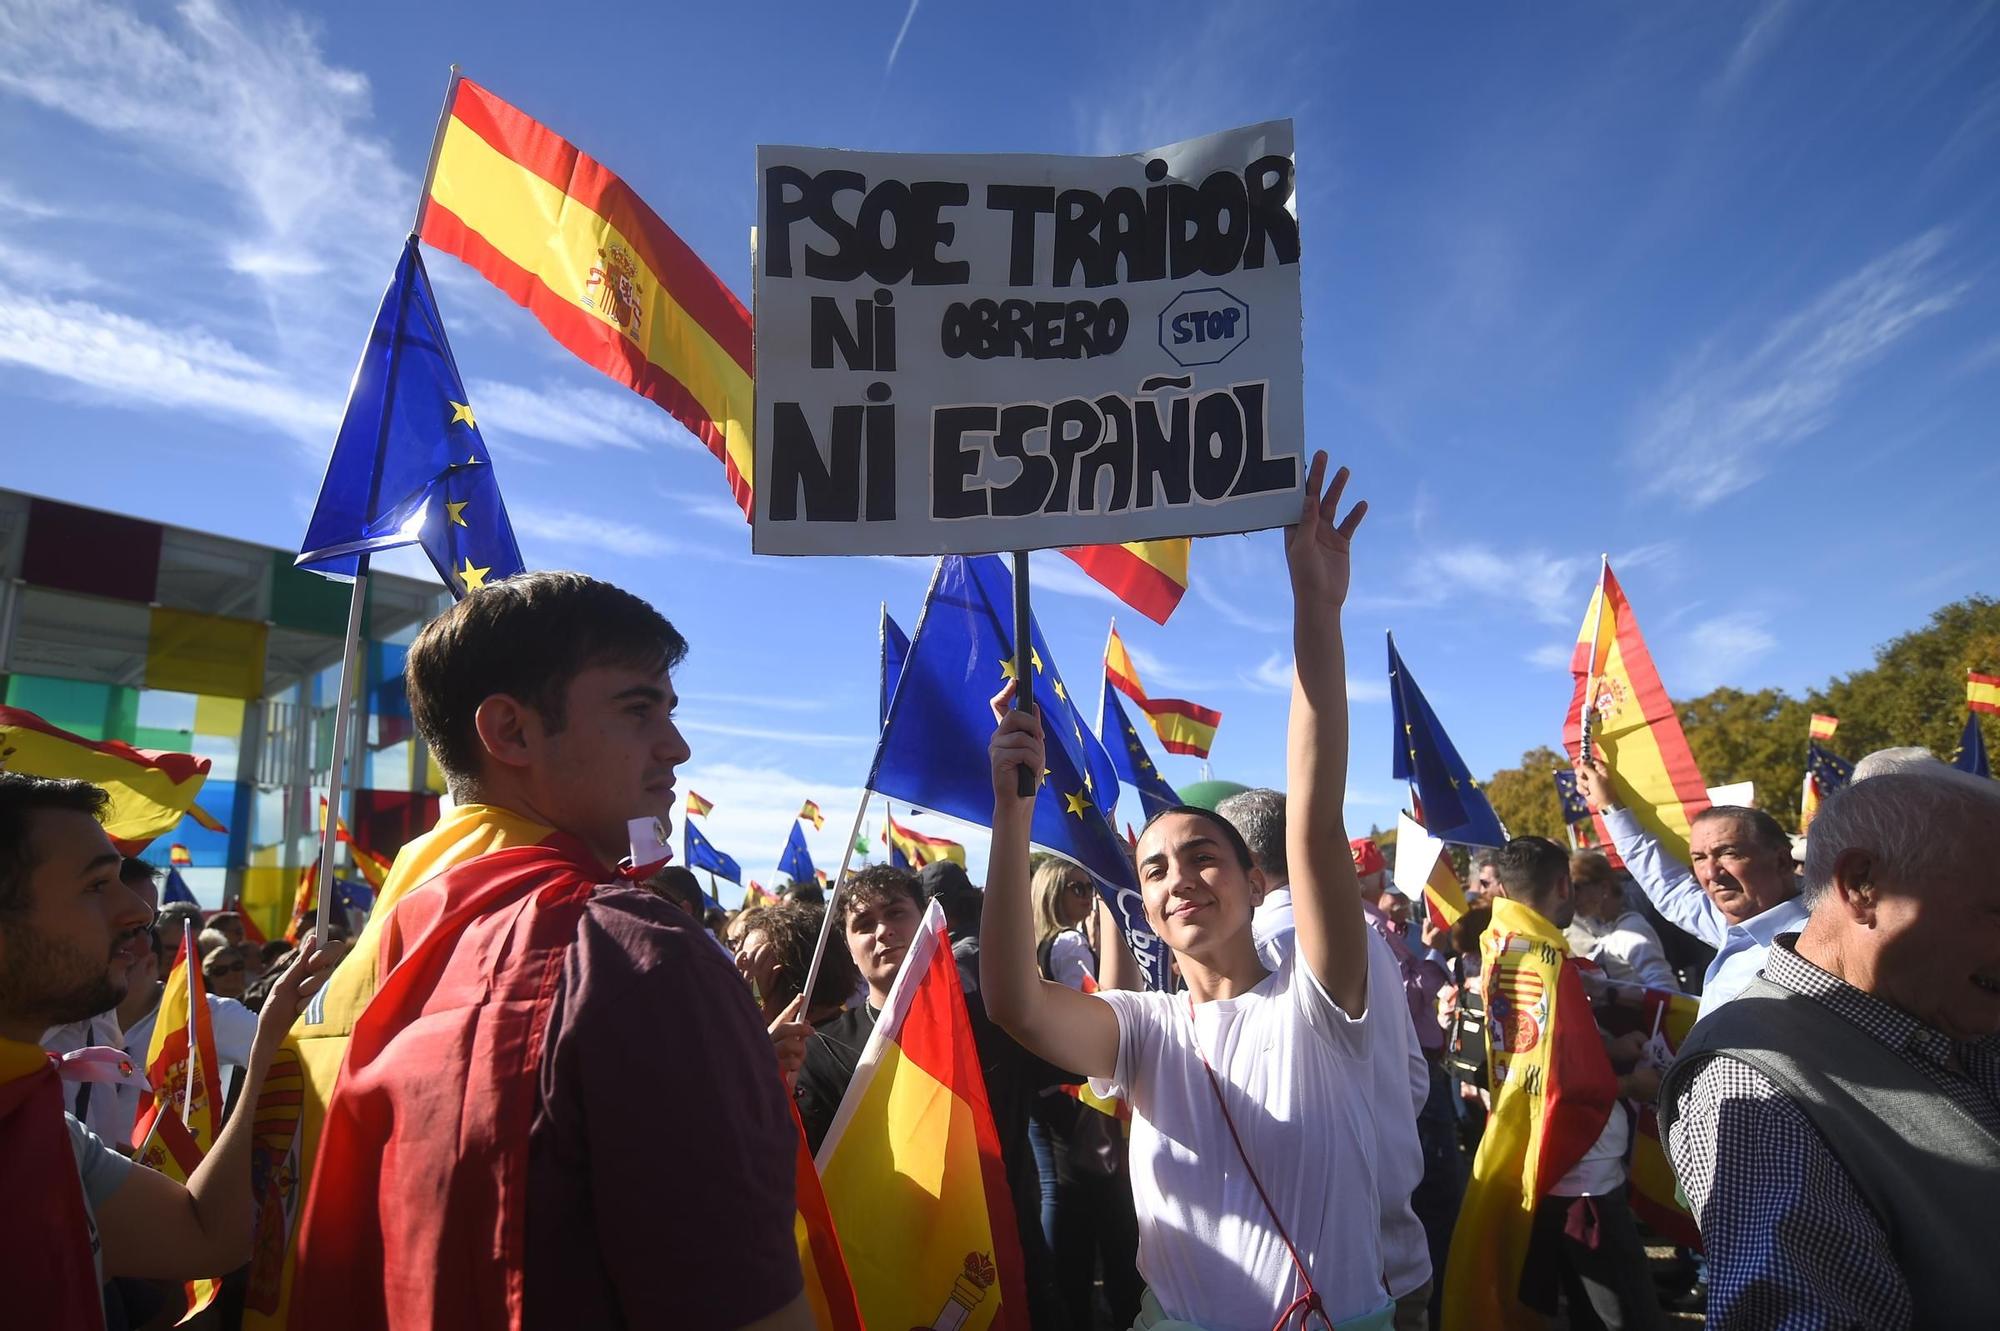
<box><xmin>0</xmin><ymin>458</ymin><xmax>2000</xmax><ymax>1331</ymax></box>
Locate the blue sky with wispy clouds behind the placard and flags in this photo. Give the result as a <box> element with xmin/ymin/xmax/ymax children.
<box><xmin>0</xmin><ymin>0</ymin><xmax>2000</xmax><ymax>891</ymax></box>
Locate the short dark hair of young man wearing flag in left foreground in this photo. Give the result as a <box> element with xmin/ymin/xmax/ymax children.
<box><xmin>404</xmin><ymin>574</ymin><xmax>688</xmax><ymax>781</ymax></box>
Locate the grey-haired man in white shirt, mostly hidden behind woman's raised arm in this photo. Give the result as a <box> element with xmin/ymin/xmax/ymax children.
<box><xmin>1216</xmin><ymin>789</ymin><xmax>1434</xmax><ymax>1331</ymax></box>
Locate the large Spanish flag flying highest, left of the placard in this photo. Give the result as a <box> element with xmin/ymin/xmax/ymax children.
<box><xmin>420</xmin><ymin>80</ymin><xmax>754</xmax><ymax>518</ymax></box>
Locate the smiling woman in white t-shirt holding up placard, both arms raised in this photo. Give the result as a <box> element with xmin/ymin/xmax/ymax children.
<box><xmin>980</xmin><ymin>454</ymin><xmax>1396</xmax><ymax>1331</ymax></box>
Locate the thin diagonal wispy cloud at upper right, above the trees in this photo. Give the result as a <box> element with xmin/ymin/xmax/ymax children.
<box><xmin>1628</xmin><ymin>228</ymin><xmax>1970</xmax><ymax>508</ymax></box>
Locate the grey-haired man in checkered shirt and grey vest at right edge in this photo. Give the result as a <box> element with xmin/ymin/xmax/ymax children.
<box><xmin>1660</xmin><ymin>765</ymin><xmax>2000</xmax><ymax>1331</ymax></box>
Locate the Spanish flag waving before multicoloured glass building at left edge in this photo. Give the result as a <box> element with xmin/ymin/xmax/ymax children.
<box><xmin>0</xmin><ymin>707</ymin><xmax>208</xmax><ymax>855</ymax></box>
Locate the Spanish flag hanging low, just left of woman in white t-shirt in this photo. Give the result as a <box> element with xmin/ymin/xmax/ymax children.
<box><xmin>818</xmin><ymin>901</ymin><xmax>1028</xmax><ymax>1331</ymax></box>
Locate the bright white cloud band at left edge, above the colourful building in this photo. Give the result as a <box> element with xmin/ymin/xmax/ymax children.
<box><xmin>0</xmin><ymin>286</ymin><xmax>340</xmax><ymax>435</ymax></box>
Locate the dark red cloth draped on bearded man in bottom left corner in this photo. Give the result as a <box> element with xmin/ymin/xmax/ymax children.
<box><xmin>0</xmin><ymin>1039</ymin><xmax>104</xmax><ymax>1327</ymax></box>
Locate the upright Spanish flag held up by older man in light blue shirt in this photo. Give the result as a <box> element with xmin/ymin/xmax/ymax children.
<box><xmin>1562</xmin><ymin>562</ymin><xmax>1708</xmax><ymax>863</ymax></box>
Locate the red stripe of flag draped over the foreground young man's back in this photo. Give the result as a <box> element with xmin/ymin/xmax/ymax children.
<box><xmin>292</xmin><ymin>833</ymin><xmax>610</xmax><ymax>1331</ymax></box>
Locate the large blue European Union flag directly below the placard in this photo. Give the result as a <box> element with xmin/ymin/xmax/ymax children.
<box><xmin>868</xmin><ymin>556</ymin><xmax>1166</xmax><ymax>987</ymax></box>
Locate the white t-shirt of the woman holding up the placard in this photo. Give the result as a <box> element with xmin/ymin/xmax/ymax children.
<box><xmin>1092</xmin><ymin>939</ymin><xmax>1404</xmax><ymax>1331</ymax></box>
